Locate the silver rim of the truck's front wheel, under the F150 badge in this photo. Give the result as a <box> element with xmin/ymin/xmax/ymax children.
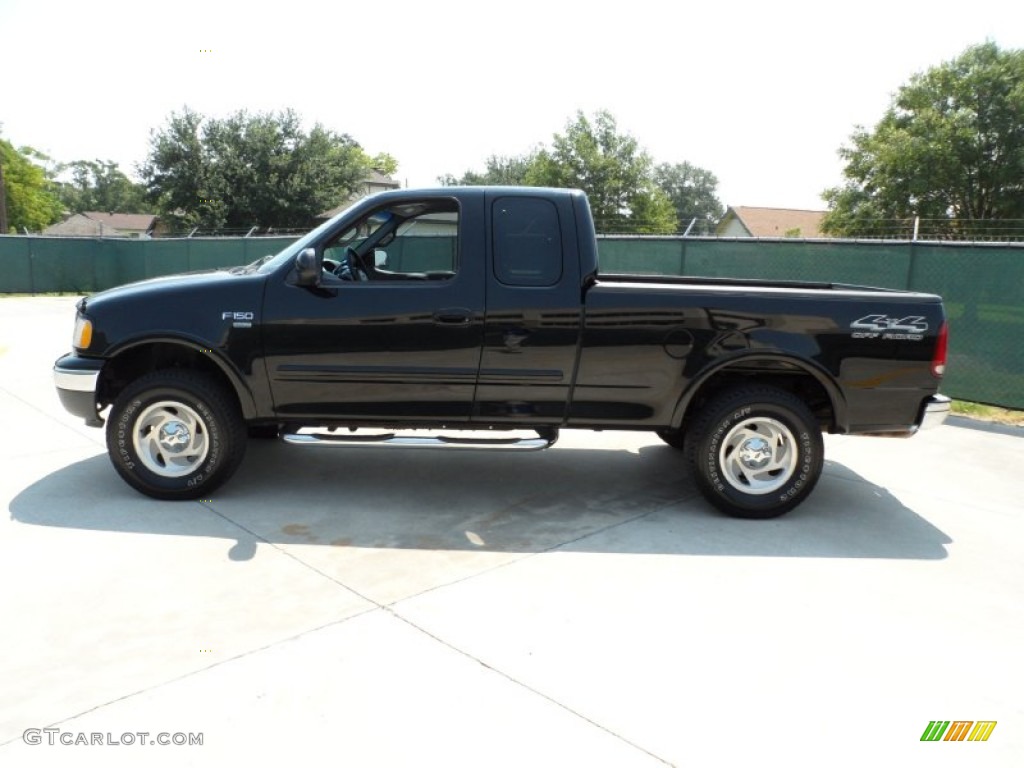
<box><xmin>132</xmin><ymin>400</ymin><xmax>210</xmax><ymax>477</ymax></box>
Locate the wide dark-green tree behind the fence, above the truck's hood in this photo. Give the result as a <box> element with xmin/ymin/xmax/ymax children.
<box><xmin>140</xmin><ymin>108</ymin><xmax>385</xmax><ymax>229</ymax></box>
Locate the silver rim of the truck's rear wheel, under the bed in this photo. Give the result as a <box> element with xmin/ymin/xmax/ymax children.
<box><xmin>718</xmin><ymin>416</ymin><xmax>798</xmax><ymax>496</ymax></box>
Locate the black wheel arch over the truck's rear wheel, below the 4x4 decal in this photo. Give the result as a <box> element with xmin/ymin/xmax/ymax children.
<box><xmin>672</xmin><ymin>353</ymin><xmax>847</xmax><ymax>432</ymax></box>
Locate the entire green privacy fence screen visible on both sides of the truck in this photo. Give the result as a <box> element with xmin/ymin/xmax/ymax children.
<box><xmin>0</xmin><ymin>236</ymin><xmax>1024</xmax><ymax>409</ymax></box>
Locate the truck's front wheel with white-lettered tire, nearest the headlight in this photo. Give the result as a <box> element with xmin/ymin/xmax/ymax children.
<box><xmin>106</xmin><ymin>369</ymin><xmax>246</xmax><ymax>500</ymax></box>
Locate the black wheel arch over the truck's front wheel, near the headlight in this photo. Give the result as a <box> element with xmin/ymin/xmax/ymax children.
<box><xmin>97</xmin><ymin>337</ymin><xmax>256</xmax><ymax>420</ymax></box>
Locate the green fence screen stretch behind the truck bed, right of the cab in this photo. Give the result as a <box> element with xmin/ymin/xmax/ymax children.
<box><xmin>599</xmin><ymin>238</ymin><xmax>1024</xmax><ymax>409</ymax></box>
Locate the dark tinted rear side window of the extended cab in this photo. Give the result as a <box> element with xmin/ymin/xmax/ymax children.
<box><xmin>492</xmin><ymin>197</ymin><xmax>562</xmax><ymax>286</ymax></box>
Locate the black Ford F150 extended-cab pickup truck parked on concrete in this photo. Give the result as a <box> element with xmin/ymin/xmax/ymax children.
<box><xmin>54</xmin><ymin>187</ymin><xmax>949</xmax><ymax>518</ymax></box>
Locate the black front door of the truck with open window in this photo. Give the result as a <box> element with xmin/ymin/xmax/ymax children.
<box><xmin>263</xmin><ymin>196</ymin><xmax>483</xmax><ymax>423</ymax></box>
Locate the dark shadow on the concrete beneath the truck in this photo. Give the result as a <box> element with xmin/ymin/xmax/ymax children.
<box><xmin>10</xmin><ymin>440</ymin><xmax>951</xmax><ymax>560</ymax></box>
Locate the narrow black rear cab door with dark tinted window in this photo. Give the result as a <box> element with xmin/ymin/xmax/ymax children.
<box><xmin>474</xmin><ymin>190</ymin><xmax>583</xmax><ymax>425</ymax></box>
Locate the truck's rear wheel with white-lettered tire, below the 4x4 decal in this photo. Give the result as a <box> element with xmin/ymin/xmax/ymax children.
<box><xmin>686</xmin><ymin>386</ymin><xmax>824</xmax><ymax>520</ymax></box>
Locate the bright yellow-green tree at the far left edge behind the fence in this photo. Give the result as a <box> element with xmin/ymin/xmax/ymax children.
<box><xmin>0</xmin><ymin>138</ymin><xmax>62</xmax><ymax>232</ymax></box>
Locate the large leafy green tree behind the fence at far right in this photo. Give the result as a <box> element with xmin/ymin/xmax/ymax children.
<box><xmin>822</xmin><ymin>42</ymin><xmax>1024</xmax><ymax>237</ymax></box>
